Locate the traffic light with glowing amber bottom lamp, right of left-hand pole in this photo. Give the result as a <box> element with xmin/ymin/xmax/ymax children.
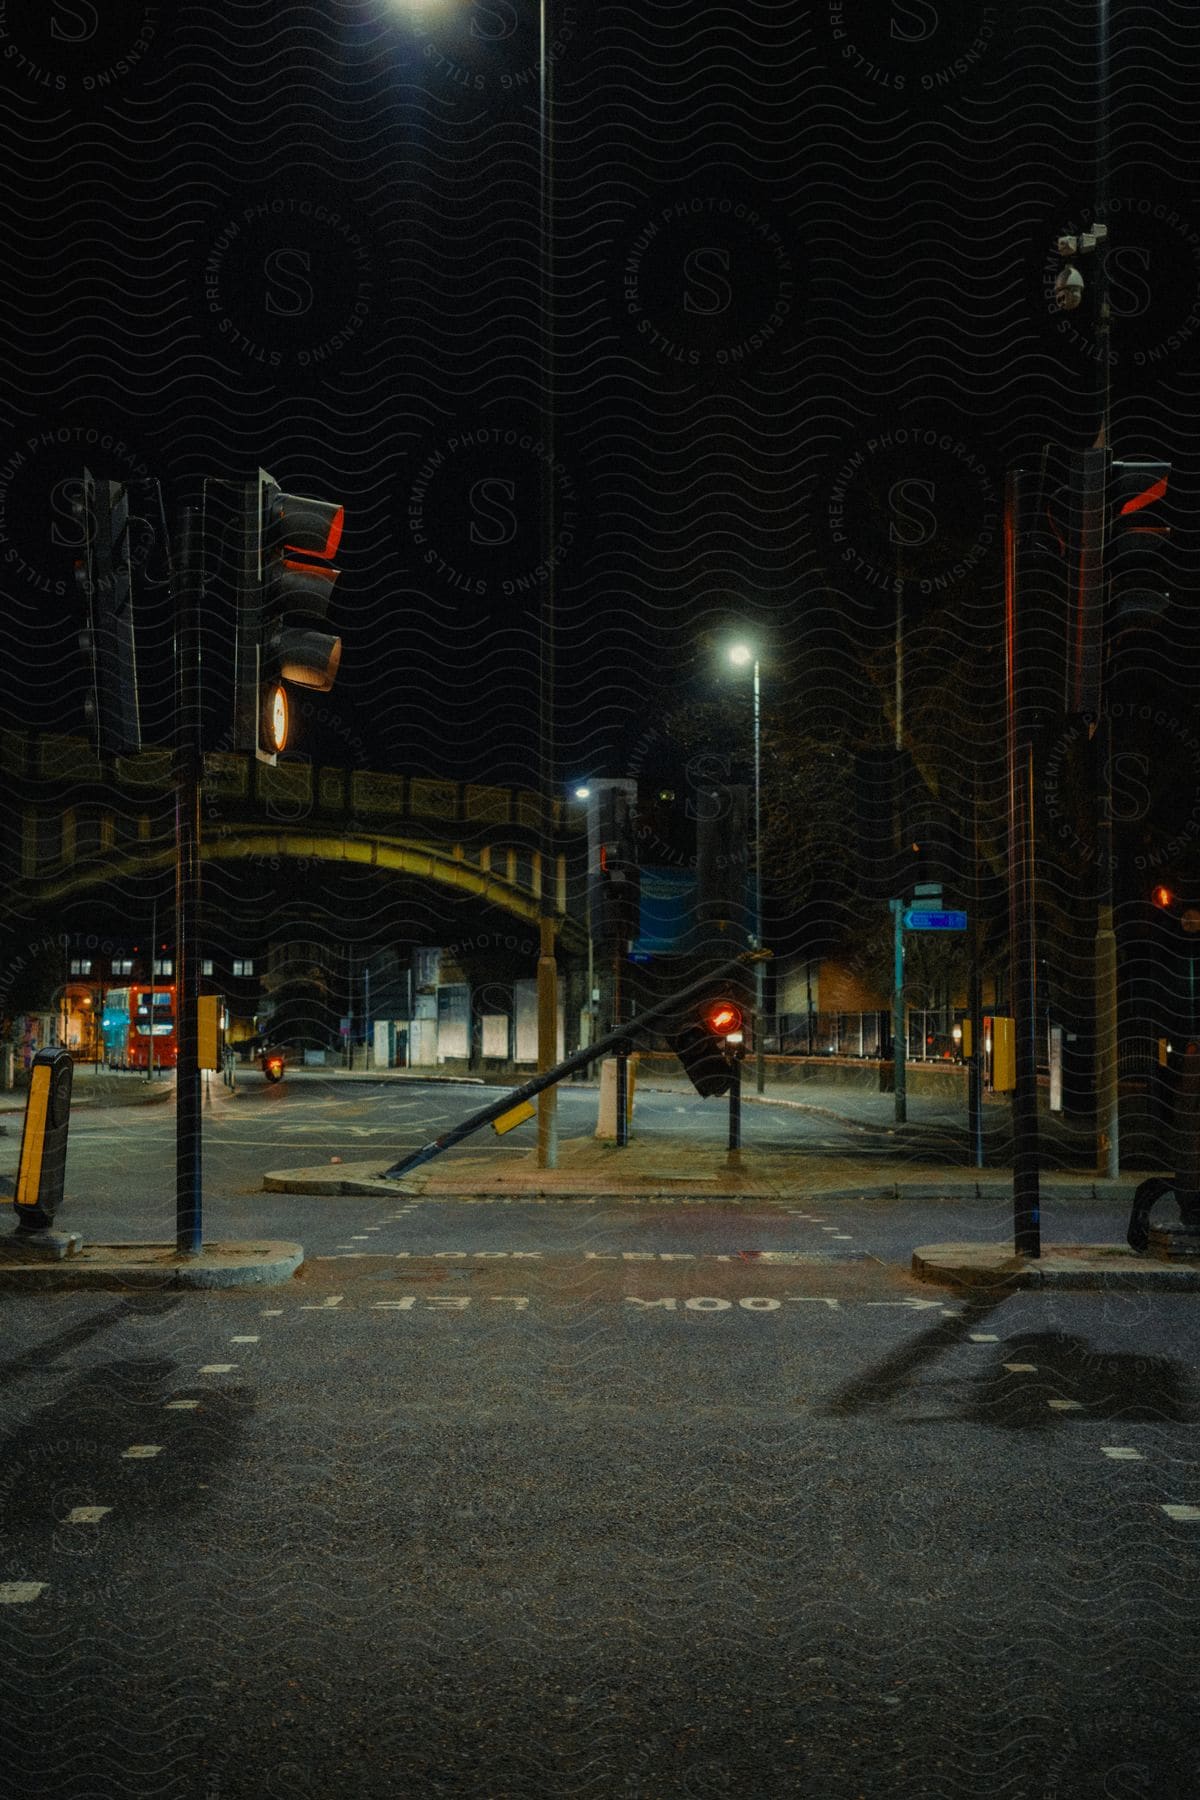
<box><xmin>234</xmin><ymin>470</ymin><xmax>345</xmax><ymax>763</ymax></box>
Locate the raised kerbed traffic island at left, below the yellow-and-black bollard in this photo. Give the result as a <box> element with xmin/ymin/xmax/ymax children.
<box><xmin>0</xmin><ymin>1233</ymin><xmax>304</xmax><ymax>1292</ymax></box>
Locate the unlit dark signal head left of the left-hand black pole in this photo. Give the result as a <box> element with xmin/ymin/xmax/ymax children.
<box><xmin>74</xmin><ymin>468</ymin><xmax>142</xmax><ymax>756</ymax></box>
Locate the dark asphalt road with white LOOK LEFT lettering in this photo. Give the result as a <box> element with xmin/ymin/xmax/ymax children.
<box><xmin>0</xmin><ymin>1084</ymin><xmax>1200</xmax><ymax>1800</ymax></box>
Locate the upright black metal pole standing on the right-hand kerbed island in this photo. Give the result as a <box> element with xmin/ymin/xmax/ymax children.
<box><xmin>1004</xmin><ymin>470</ymin><xmax>1042</xmax><ymax>1256</ymax></box>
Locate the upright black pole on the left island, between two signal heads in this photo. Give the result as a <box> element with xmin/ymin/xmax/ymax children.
<box><xmin>174</xmin><ymin>508</ymin><xmax>203</xmax><ymax>1256</ymax></box>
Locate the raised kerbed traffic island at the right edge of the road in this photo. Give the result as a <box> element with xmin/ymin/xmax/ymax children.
<box><xmin>912</xmin><ymin>1244</ymin><xmax>1200</xmax><ymax>1292</ymax></box>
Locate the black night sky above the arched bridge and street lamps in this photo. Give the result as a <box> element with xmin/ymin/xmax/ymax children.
<box><xmin>0</xmin><ymin>0</ymin><xmax>1200</xmax><ymax>943</ymax></box>
